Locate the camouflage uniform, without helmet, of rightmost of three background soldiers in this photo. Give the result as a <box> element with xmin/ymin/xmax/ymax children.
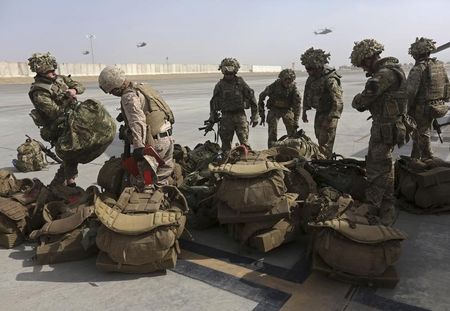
<box><xmin>303</xmin><ymin>67</ymin><xmax>343</xmax><ymax>158</ymax></box>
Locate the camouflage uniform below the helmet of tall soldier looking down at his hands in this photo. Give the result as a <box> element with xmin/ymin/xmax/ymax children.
<box><xmin>352</xmin><ymin>57</ymin><xmax>406</xmax><ymax>219</ymax></box>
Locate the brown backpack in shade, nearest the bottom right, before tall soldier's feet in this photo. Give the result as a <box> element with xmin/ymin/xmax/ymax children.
<box><xmin>310</xmin><ymin>219</ymin><xmax>406</xmax><ymax>277</ymax></box>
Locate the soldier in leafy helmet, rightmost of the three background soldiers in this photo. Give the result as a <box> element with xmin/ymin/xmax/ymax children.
<box><xmin>300</xmin><ymin>48</ymin><xmax>343</xmax><ymax>158</ymax></box>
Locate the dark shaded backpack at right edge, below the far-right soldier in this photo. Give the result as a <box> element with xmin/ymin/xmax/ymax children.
<box><xmin>395</xmin><ymin>156</ymin><xmax>450</xmax><ymax>213</ymax></box>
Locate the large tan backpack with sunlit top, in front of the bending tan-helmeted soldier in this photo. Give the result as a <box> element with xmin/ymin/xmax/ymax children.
<box><xmin>95</xmin><ymin>186</ymin><xmax>188</xmax><ymax>272</ymax></box>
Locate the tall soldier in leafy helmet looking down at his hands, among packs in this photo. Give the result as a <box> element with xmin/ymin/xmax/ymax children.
<box><xmin>350</xmin><ymin>39</ymin><xmax>407</xmax><ymax>225</ymax></box>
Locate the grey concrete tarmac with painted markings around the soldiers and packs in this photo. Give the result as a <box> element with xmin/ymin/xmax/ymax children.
<box><xmin>0</xmin><ymin>72</ymin><xmax>450</xmax><ymax>310</ymax></box>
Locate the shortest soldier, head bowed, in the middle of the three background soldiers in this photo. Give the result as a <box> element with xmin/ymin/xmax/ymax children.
<box><xmin>258</xmin><ymin>69</ymin><xmax>302</xmax><ymax>148</ymax></box>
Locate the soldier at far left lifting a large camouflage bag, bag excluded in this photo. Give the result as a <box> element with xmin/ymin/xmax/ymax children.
<box><xmin>28</xmin><ymin>53</ymin><xmax>84</xmax><ymax>186</ymax></box>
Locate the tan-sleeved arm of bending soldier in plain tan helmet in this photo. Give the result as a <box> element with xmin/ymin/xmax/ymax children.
<box><xmin>121</xmin><ymin>92</ymin><xmax>147</xmax><ymax>148</ymax></box>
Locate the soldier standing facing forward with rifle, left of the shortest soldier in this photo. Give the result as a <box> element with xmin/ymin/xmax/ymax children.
<box><xmin>206</xmin><ymin>58</ymin><xmax>259</xmax><ymax>153</ymax></box>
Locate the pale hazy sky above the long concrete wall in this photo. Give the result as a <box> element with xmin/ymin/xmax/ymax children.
<box><xmin>0</xmin><ymin>0</ymin><xmax>450</xmax><ymax>67</ymax></box>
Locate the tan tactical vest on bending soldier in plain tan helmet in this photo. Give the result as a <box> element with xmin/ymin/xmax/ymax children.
<box><xmin>134</xmin><ymin>84</ymin><xmax>175</xmax><ymax>136</ymax></box>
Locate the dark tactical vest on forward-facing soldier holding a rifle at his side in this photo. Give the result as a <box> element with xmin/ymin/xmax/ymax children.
<box><xmin>219</xmin><ymin>77</ymin><xmax>249</xmax><ymax>112</ymax></box>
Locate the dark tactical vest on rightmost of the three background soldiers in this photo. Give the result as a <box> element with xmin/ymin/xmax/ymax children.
<box><xmin>303</xmin><ymin>67</ymin><xmax>343</xmax><ymax>114</ymax></box>
